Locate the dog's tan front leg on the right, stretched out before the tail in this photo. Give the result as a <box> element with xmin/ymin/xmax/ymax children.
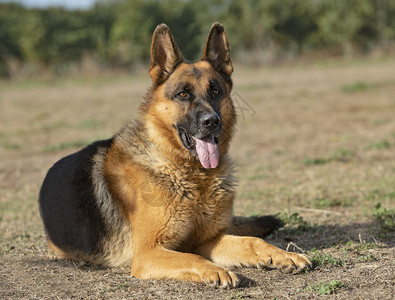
<box><xmin>196</xmin><ymin>235</ymin><xmax>311</xmax><ymax>273</ymax></box>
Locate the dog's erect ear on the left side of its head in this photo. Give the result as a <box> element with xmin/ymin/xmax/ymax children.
<box><xmin>149</xmin><ymin>24</ymin><xmax>183</xmax><ymax>85</ymax></box>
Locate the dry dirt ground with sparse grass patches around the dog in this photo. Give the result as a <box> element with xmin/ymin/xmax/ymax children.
<box><xmin>0</xmin><ymin>58</ymin><xmax>395</xmax><ymax>299</ymax></box>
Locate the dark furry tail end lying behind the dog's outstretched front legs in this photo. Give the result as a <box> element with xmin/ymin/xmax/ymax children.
<box><xmin>228</xmin><ymin>216</ymin><xmax>284</xmax><ymax>238</ymax></box>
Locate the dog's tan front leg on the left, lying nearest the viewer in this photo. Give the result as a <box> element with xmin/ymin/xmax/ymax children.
<box><xmin>131</xmin><ymin>247</ymin><xmax>239</xmax><ymax>287</ymax></box>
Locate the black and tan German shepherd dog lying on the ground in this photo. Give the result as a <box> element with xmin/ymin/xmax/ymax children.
<box><xmin>39</xmin><ymin>23</ymin><xmax>311</xmax><ymax>287</ymax></box>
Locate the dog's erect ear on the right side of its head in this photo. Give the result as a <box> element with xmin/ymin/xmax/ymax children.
<box><xmin>202</xmin><ymin>23</ymin><xmax>233</xmax><ymax>76</ymax></box>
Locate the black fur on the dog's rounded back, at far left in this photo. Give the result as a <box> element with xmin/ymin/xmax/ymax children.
<box><xmin>39</xmin><ymin>140</ymin><xmax>112</xmax><ymax>254</ymax></box>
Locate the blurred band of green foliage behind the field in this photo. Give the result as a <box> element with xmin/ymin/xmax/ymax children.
<box><xmin>0</xmin><ymin>0</ymin><xmax>395</xmax><ymax>77</ymax></box>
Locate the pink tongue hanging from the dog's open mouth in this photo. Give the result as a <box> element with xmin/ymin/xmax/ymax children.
<box><xmin>194</xmin><ymin>135</ymin><xmax>219</xmax><ymax>169</ymax></box>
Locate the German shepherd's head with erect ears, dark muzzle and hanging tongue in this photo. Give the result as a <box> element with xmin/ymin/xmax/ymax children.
<box><xmin>143</xmin><ymin>23</ymin><xmax>236</xmax><ymax>169</ymax></box>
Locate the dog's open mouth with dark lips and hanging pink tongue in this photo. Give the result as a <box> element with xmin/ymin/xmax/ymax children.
<box><xmin>178</xmin><ymin>127</ymin><xmax>219</xmax><ymax>169</ymax></box>
